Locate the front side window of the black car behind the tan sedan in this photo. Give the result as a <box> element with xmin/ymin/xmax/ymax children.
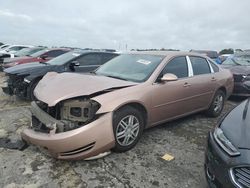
<box><xmin>77</xmin><ymin>53</ymin><xmax>102</xmax><ymax>66</ymax></box>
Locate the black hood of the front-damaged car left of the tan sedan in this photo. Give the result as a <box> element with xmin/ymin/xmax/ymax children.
<box><xmin>4</xmin><ymin>63</ymin><xmax>55</xmax><ymax>75</ymax></box>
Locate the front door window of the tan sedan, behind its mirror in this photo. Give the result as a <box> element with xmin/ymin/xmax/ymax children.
<box><xmin>162</xmin><ymin>57</ymin><xmax>188</xmax><ymax>78</ymax></box>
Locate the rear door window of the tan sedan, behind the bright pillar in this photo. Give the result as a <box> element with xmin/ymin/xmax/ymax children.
<box><xmin>189</xmin><ymin>56</ymin><xmax>211</xmax><ymax>75</ymax></box>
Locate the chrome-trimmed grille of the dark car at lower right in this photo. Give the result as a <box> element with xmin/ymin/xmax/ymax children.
<box><xmin>232</xmin><ymin>167</ymin><xmax>250</xmax><ymax>188</ymax></box>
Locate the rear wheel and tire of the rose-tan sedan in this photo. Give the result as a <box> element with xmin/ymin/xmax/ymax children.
<box><xmin>206</xmin><ymin>90</ymin><xmax>226</xmax><ymax>117</ymax></box>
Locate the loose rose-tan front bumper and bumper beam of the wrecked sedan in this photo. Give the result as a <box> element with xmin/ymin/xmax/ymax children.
<box><xmin>21</xmin><ymin>102</ymin><xmax>115</xmax><ymax>159</ymax></box>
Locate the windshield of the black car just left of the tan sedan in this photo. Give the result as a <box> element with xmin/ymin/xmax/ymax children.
<box><xmin>47</xmin><ymin>51</ymin><xmax>83</xmax><ymax>65</ymax></box>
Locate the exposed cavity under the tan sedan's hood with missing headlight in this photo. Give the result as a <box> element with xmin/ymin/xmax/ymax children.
<box><xmin>31</xmin><ymin>98</ymin><xmax>100</xmax><ymax>133</ymax></box>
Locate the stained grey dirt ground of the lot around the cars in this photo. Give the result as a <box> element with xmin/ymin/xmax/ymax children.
<box><xmin>0</xmin><ymin>73</ymin><xmax>239</xmax><ymax>188</ymax></box>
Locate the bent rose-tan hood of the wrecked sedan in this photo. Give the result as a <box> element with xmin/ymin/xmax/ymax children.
<box><xmin>34</xmin><ymin>72</ymin><xmax>138</xmax><ymax>106</ymax></box>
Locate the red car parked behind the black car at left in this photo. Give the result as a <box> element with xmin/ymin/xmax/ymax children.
<box><xmin>2</xmin><ymin>48</ymin><xmax>71</xmax><ymax>69</ymax></box>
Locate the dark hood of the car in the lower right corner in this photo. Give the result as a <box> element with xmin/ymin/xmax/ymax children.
<box><xmin>220</xmin><ymin>99</ymin><xmax>250</xmax><ymax>149</ymax></box>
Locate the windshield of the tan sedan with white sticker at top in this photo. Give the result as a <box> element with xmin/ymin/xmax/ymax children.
<box><xmin>95</xmin><ymin>54</ymin><xmax>165</xmax><ymax>82</ymax></box>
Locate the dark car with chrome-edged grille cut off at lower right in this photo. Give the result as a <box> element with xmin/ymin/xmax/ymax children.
<box><xmin>205</xmin><ymin>99</ymin><xmax>250</xmax><ymax>188</ymax></box>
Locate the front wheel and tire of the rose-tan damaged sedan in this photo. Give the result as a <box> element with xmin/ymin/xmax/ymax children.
<box><xmin>113</xmin><ymin>106</ymin><xmax>144</xmax><ymax>152</ymax></box>
